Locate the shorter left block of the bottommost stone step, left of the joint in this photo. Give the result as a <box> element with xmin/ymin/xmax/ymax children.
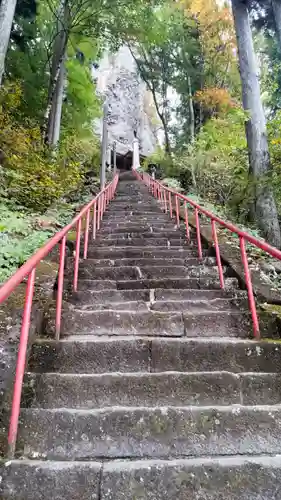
<box><xmin>0</xmin><ymin>460</ymin><xmax>102</xmax><ymax>500</ymax></box>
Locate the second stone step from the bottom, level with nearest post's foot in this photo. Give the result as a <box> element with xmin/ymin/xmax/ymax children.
<box><xmin>19</xmin><ymin>405</ymin><xmax>281</xmax><ymax>460</ymax></box>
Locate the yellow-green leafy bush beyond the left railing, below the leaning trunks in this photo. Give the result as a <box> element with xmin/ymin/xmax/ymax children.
<box><xmin>0</xmin><ymin>84</ymin><xmax>97</xmax><ymax>211</ymax></box>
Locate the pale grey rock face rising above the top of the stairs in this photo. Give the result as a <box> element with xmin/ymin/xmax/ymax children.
<box><xmin>94</xmin><ymin>47</ymin><xmax>159</xmax><ymax>156</ymax></box>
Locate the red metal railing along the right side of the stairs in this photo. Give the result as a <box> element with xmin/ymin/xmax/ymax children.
<box><xmin>137</xmin><ymin>171</ymin><xmax>281</xmax><ymax>339</ymax></box>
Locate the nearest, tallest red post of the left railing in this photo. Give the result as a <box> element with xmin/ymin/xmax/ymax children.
<box><xmin>8</xmin><ymin>268</ymin><xmax>36</xmax><ymax>459</ymax></box>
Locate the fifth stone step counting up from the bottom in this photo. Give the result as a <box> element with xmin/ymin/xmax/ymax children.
<box><xmin>45</xmin><ymin>302</ymin><xmax>245</xmax><ymax>337</ymax></box>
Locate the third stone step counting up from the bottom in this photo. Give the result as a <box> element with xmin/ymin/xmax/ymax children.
<box><xmin>25</xmin><ymin>371</ymin><xmax>281</xmax><ymax>409</ymax></box>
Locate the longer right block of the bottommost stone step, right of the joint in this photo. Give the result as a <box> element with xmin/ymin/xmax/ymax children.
<box><xmin>100</xmin><ymin>456</ymin><xmax>281</xmax><ymax>500</ymax></box>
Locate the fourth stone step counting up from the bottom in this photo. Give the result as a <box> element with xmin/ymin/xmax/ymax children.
<box><xmin>29</xmin><ymin>336</ymin><xmax>281</xmax><ymax>373</ymax></box>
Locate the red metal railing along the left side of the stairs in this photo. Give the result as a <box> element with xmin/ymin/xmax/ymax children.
<box><xmin>0</xmin><ymin>174</ymin><xmax>118</xmax><ymax>458</ymax></box>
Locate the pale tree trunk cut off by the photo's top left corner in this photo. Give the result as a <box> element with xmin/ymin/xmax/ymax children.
<box><xmin>0</xmin><ymin>0</ymin><xmax>17</xmax><ymax>85</ymax></box>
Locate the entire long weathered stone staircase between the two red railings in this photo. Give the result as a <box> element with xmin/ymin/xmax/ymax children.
<box><xmin>0</xmin><ymin>173</ymin><xmax>281</xmax><ymax>500</ymax></box>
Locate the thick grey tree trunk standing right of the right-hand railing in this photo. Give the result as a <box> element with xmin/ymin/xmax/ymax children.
<box><xmin>232</xmin><ymin>0</ymin><xmax>281</xmax><ymax>247</ymax></box>
